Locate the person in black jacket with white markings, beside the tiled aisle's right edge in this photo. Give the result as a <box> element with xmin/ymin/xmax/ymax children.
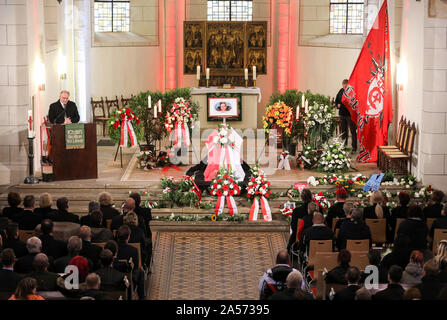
<box><xmin>259</xmin><ymin>250</ymin><xmax>304</xmax><ymax>300</ymax></box>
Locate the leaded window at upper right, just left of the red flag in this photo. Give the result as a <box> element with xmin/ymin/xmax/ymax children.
<box><xmin>330</xmin><ymin>0</ymin><xmax>364</xmax><ymax>34</ymax></box>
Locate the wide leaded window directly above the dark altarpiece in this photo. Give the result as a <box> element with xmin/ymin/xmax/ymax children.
<box><xmin>208</xmin><ymin>0</ymin><xmax>253</xmax><ymax>21</ymax></box>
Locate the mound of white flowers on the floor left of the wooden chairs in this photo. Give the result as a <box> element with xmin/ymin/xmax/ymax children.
<box><xmin>318</xmin><ymin>139</ymin><xmax>351</xmax><ymax>172</ymax></box>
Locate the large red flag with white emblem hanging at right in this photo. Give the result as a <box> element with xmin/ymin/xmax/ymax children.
<box><xmin>342</xmin><ymin>0</ymin><xmax>393</xmax><ymax>162</ymax></box>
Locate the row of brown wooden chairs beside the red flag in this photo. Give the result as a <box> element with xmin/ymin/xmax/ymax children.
<box><xmin>377</xmin><ymin>116</ymin><xmax>417</xmax><ymax>174</ymax></box>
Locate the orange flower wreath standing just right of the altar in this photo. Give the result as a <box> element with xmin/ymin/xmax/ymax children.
<box><xmin>262</xmin><ymin>101</ymin><xmax>293</xmax><ymax>136</ymax></box>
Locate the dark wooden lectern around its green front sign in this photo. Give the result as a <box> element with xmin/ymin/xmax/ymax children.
<box><xmin>50</xmin><ymin>123</ymin><xmax>98</xmax><ymax>181</ymax></box>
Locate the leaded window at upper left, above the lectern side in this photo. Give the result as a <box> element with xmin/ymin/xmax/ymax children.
<box><xmin>94</xmin><ymin>0</ymin><xmax>130</xmax><ymax>32</ymax></box>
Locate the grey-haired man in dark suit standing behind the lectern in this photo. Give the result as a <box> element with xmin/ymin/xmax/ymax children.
<box><xmin>48</xmin><ymin>90</ymin><xmax>79</xmax><ymax>124</ymax></box>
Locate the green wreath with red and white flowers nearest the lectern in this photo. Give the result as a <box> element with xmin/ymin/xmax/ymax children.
<box><xmin>107</xmin><ymin>106</ymin><xmax>143</xmax><ymax>146</ymax></box>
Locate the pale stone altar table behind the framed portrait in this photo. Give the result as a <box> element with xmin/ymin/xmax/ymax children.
<box><xmin>191</xmin><ymin>87</ymin><xmax>261</xmax><ymax>129</ymax></box>
